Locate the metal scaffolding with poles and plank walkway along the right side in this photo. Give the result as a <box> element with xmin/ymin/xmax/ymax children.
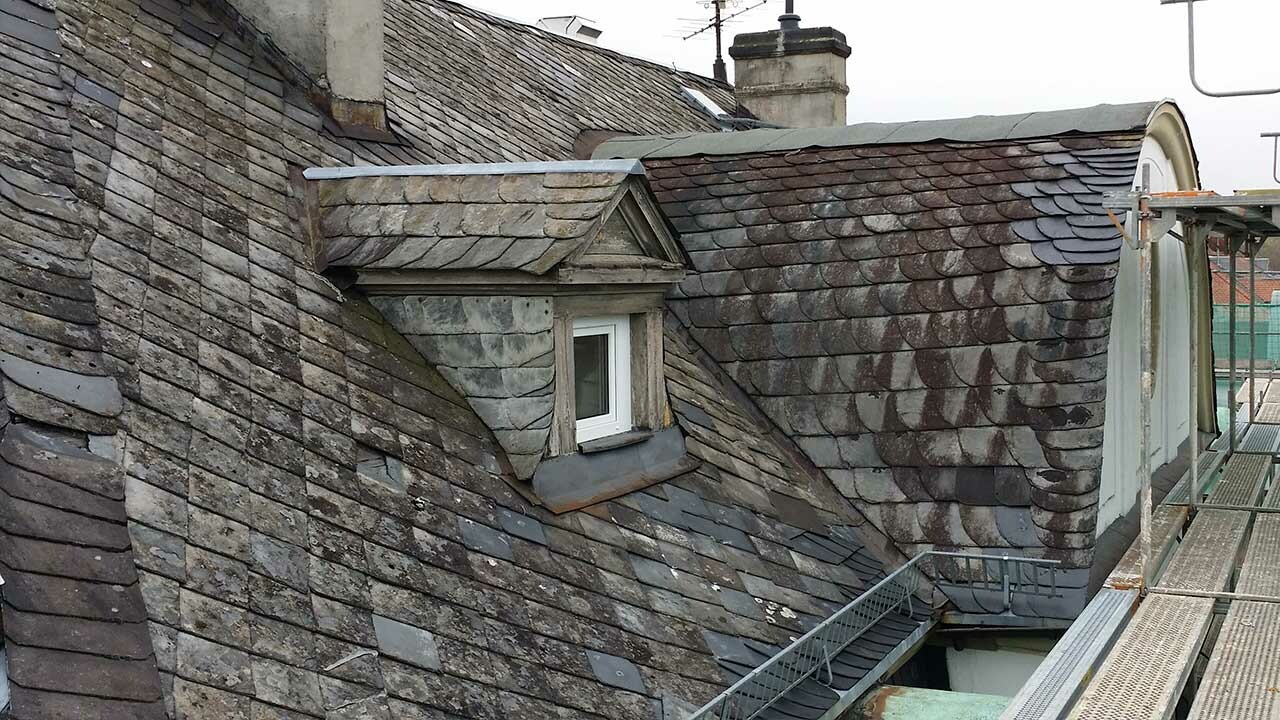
<box><xmin>1002</xmin><ymin>191</ymin><xmax>1280</xmax><ymax>720</ymax></box>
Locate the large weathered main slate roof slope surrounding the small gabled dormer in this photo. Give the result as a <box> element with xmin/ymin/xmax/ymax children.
<box><xmin>0</xmin><ymin>0</ymin><xmax>916</xmax><ymax>720</ymax></box>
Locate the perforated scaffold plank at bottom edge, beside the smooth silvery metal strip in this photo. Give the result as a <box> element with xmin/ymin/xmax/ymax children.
<box><xmin>1070</xmin><ymin>594</ymin><xmax>1213</xmax><ymax>720</ymax></box>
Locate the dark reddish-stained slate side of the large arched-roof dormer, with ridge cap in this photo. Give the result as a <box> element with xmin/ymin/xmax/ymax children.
<box><xmin>598</xmin><ymin>104</ymin><xmax>1160</xmax><ymax>618</ymax></box>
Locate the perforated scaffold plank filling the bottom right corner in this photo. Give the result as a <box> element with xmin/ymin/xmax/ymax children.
<box><xmin>1188</xmin><ymin>601</ymin><xmax>1280</xmax><ymax>720</ymax></box>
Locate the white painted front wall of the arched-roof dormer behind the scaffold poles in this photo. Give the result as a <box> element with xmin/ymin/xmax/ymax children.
<box><xmin>1098</xmin><ymin>137</ymin><xmax>1190</xmax><ymax>533</ymax></box>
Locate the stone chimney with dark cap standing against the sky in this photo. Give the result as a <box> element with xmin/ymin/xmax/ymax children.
<box><xmin>728</xmin><ymin>0</ymin><xmax>849</xmax><ymax>128</ymax></box>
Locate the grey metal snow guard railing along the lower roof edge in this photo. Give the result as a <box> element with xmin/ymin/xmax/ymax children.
<box><xmin>689</xmin><ymin>551</ymin><xmax>1059</xmax><ymax>720</ymax></box>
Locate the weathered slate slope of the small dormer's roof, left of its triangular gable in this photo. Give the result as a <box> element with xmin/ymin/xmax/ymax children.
<box><xmin>319</xmin><ymin>161</ymin><xmax>646</xmax><ymax>275</ymax></box>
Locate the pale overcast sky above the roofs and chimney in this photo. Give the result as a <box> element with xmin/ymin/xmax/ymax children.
<box><xmin>463</xmin><ymin>0</ymin><xmax>1280</xmax><ymax>192</ymax></box>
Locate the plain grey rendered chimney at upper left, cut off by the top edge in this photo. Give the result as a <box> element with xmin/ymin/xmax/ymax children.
<box><xmin>230</xmin><ymin>0</ymin><xmax>388</xmax><ymax>133</ymax></box>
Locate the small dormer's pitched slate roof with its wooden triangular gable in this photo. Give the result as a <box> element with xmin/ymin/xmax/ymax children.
<box><xmin>306</xmin><ymin>160</ymin><xmax>685</xmax><ymax>286</ymax></box>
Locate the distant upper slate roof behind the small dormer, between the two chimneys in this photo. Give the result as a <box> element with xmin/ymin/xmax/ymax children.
<box><xmin>385</xmin><ymin>0</ymin><xmax>746</xmax><ymax>163</ymax></box>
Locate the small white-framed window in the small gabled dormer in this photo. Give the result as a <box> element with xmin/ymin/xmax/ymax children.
<box><xmin>573</xmin><ymin>315</ymin><xmax>631</xmax><ymax>443</ymax></box>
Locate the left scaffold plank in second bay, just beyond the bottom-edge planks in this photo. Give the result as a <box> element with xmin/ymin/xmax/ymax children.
<box><xmin>1160</xmin><ymin>510</ymin><xmax>1249</xmax><ymax>591</ymax></box>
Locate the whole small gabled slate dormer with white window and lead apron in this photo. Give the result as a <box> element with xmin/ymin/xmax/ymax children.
<box><xmin>305</xmin><ymin>160</ymin><xmax>690</xmax><ymax>510</ymax></box>
